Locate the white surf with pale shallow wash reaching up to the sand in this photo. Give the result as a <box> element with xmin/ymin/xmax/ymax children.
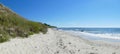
<box><xmin>61</xmin><ymin>30</ymin><xmax>120</xmax><ymax>42</ymax></box>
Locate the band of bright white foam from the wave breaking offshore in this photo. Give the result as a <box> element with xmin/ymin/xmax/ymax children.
<box><xmin>65</xmin><ymin>31</ymin><xmax>120</xmax><ymax>40</ymax></box>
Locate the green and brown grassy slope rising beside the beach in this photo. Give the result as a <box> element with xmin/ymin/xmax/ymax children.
<box><xmin>0</xmin><ymin>4</ymin><xmax>48</xmax><ymax>42</ymax></box>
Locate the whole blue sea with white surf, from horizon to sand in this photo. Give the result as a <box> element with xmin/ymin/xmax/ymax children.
<box><xmin>58</xmin><ymin>28</ymin><xmax>120</xmax><ymax>42</ymax></box>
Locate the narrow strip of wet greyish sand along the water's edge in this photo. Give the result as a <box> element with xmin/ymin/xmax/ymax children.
<box><xmin>60</xmin><ymin>30</ymin><xmax>120</xmax><ymax>47</ymax></box>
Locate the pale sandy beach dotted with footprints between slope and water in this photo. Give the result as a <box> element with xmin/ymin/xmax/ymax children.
<box><xmin>0</xmin><ymin>29</ymin><xmax>120</xmax><ymax>54</ymax></box>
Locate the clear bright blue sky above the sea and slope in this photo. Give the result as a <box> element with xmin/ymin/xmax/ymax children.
<box><xmin>0</xmin><ymin>0</ymin><xmax>120</xmax><ymax>28</ymax></box>
